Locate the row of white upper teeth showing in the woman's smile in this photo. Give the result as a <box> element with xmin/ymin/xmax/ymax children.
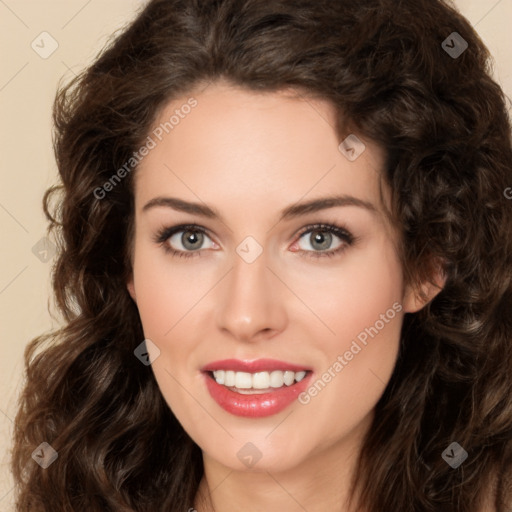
<box><xmin>213</xmin><ymin>370</ymin><xmax>306</xmax><ymax>389</ymax></box>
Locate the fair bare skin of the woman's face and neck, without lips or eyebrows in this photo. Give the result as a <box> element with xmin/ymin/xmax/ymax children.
<box><xmin>127</xmin><ymin>82</ymin><xmax>442</xmax><ymax>512</ymax></box>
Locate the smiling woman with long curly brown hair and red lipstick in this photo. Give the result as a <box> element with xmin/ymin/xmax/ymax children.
<box><xmin>13</xmin><ymin>0</ymin><xmax>512</xmax><ymax>512</ymax></box>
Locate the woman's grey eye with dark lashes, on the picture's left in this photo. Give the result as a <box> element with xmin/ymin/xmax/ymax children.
<box><xmin>155</xmin><ymin>225</ymin><xmax>218</xmax><ymax>258</ymax></box>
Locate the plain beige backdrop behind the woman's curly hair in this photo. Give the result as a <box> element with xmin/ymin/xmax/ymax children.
<box><xmin>0</xmin><ymin>0</ymin><xmax>512</xmax><ymax>511</ymax></box>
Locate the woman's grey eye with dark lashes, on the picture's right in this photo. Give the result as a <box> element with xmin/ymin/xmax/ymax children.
<box><xmin>292</xmin><ymin>224</ymin><xmax>356</xmax><ymax>258</ymax></box>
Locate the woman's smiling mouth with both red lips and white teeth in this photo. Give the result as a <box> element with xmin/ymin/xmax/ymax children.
<box><xmin>202</xmin><ymin>359</ymin><xmax>313</xmax><ymax>418</ymax></box>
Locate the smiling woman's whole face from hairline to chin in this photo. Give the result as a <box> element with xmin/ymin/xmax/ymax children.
<box><xmin>128</xmin><ymin>79</ymin><xmax>424</xmax><ymax>471</ymax></box>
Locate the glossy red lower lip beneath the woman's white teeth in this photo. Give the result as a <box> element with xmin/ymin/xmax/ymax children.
<box><xmin>204</xmin><ymin>373</ymin><xmax>312</xmax><ymax>418</ymax></box>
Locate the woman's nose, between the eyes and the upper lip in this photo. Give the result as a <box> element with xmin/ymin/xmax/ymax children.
<box><xmin>216</xmin><ymin>246</ymin><xmax>288</xmax><ymax>342</ymax></box>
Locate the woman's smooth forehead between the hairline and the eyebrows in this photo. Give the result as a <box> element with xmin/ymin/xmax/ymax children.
<box><xmin>135</xmin><ymin>83</ymin><xmax>384</xmax><ymax>219</ymax></box>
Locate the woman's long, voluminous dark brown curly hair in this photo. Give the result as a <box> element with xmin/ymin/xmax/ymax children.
<box><xmin>12</xmin><ymin>0</ymin><xmax>512</xmax><ymax>512</ymax></box>
